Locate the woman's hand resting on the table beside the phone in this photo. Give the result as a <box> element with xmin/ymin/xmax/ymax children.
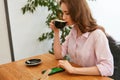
<box><xmin>58</xmin><ymin>60</ymin><xmax>74</xmax><ymax>73</ymax></box>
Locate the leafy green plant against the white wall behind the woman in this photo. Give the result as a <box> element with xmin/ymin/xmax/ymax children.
<box><xmin>21</xmin><ymin>0</ymin><xmax>70</xmax><ymax>53</ymax></box>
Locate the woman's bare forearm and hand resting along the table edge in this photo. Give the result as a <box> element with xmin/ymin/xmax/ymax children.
<box><xmin>58</xmin><ymin>60</ymin><xmax>100</xmax><ymax>75</ymax></box>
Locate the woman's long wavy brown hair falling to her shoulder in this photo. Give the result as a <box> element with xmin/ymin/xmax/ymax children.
<box><xmin>60</xmin><ymin>0</ymin><xmax>104</xmax><ymax>33</ymax></box>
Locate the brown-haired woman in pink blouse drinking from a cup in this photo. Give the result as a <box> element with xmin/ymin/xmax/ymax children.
<box><xmin>50</xmin><ymin>0</ymin><xmax>113</xmax><ymax>76</ymax></box>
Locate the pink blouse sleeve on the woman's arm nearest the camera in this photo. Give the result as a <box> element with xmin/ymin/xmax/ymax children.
<box><xmin>94</xmin><ymin>30</ymin><xmax>114</xmax><ymax>76</ymax></box>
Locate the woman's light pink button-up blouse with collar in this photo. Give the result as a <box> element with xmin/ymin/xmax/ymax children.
<box><xmin>62</xmin><ymin>27</ymin><xmax>114</xmax><ymax>76</ymax></box>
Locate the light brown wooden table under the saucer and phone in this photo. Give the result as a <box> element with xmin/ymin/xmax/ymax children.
<box><xmin>0</xmin><ymin>53</ymin><xmax>112</xmax><ymax>80</ymax></box>
